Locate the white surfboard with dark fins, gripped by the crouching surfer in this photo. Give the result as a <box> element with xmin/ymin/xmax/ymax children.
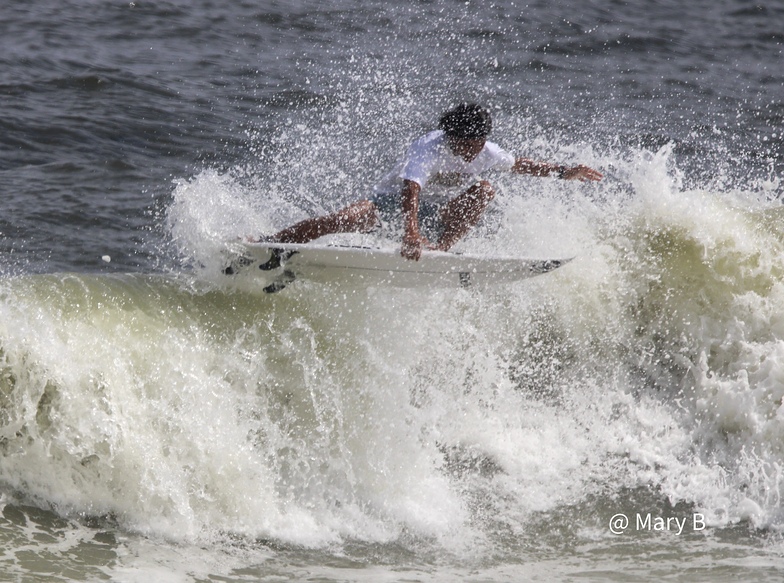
<box><xmin>223</xmin><ymin>243</ymin><xmax>572</xmax><ymax>293</ymax></box>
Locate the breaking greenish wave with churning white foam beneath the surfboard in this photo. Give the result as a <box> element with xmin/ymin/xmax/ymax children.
<box><xmin>0</xmin><ymin>148</ymin><xmax>784</xmax><ymax>563</ymax></box>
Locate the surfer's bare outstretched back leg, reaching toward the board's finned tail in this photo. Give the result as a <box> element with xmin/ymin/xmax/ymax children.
<box><xmin>270</xmin><ymin>200</ymin><xmax>378</xmax><ymax>243</ymax></box>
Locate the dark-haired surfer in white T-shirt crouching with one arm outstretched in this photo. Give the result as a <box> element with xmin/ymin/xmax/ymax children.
<box><xmin>264</xmin><ymin>103</ymin><xmax>602</xmax><ymax>260</ymax></box>
